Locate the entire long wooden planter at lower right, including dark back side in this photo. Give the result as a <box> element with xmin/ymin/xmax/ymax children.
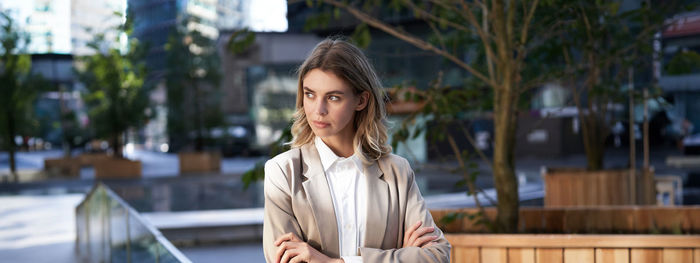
<box><xmin>431</xmin><ymin>206</ymin><xmax>700</xmax><ymax>263</ymax></box>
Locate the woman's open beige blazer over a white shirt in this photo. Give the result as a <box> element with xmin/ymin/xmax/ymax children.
<box><xmin>263</xmin><ymin>142</ymin><xmax>450</xmax><ymax>263</ymax></box>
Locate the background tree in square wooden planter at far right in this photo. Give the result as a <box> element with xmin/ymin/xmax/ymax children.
<box><xmin>555</xmin><ymin>0</ymin><xmax>685</xmax><ymax>170</ymax></box>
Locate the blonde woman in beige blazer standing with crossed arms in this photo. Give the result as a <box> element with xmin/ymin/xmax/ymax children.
<box><xmin>263</xmin><ymin>39</ymin><xmax>450</xmax><ymax>263</ymax></box>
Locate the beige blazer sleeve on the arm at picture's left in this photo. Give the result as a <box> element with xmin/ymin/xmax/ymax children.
<box><xmin>263</xmin><ymin>160</ymin><xmax>303</xmax><ymax>262</ymax></box>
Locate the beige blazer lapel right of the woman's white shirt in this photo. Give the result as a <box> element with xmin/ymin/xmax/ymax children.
<box><xmin>364</xmin><ymin>161</ymin><xmax>389</xmax><ymax>248</ymax></box>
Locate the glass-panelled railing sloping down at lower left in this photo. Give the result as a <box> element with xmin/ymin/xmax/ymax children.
<box><xmin>75</xmin><ymin>183</ymin><xmax>191</xmax><ymax>263</ymax></box>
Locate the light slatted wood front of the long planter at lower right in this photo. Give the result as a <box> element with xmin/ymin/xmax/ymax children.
<box><xmin>445</xmin><ymin>234</ymin><xmax>700</xmax><ymax>263</ymax></box>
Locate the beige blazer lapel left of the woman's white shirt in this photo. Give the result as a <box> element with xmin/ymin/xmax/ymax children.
<box><xmin>301</xmin><ymin>143</ymin><xmax>340</xmax><ymax>258</ymax></box>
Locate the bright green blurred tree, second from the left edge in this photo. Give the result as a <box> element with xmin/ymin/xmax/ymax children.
<box><xmin>76</xmin><ymin>13</ymin><xmax>150</xmax><ymax>158</ymax></box>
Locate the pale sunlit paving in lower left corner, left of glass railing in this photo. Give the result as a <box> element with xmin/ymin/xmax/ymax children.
<box><xmin>0</xmin><ymin>194</ymin><xmax>84</xmax><ymax>263</ymax></box>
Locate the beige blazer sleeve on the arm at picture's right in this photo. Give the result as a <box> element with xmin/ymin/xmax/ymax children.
<box><xmin>360</xmin><ymin>159</ymin><xmax>451</xmax><ymax>263</ymax></box>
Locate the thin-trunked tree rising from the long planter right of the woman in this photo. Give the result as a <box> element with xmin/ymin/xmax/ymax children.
<box><xmin>307</xmin><ymin>0</ymin><xmax>576</xmax><ymax>232</ymax></box>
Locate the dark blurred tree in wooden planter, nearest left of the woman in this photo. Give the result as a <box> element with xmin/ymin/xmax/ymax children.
<box><xmin>165</xmin><ymin>17</ymin><xmax>224</xmax><ymax>151</ymax></box>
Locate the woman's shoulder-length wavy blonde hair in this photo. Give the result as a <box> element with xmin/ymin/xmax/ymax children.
<box><xmin>289</xmin><ymin>38</ymin><xmax>391</xmax><ymax>163</ymax></box>
